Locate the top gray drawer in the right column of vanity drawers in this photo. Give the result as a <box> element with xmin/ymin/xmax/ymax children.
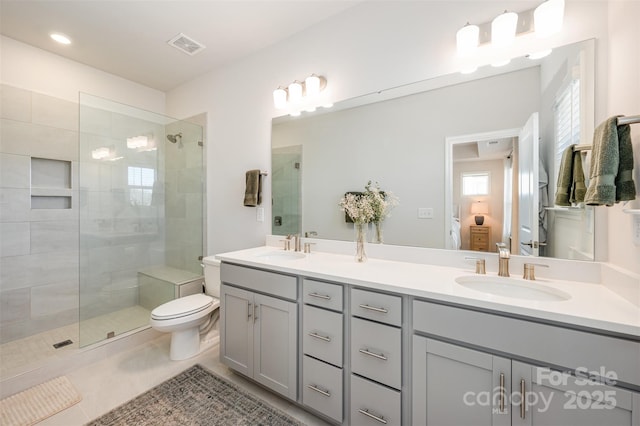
<box><xmin>351</xmin><ymin>289</ymin><xmax>402</xmax><ymax>327</ymax></box>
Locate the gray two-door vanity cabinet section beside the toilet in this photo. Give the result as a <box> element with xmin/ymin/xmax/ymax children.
<box><xmin>220</xmin><ymin>263</ymin><xmax>298</xmax><ymax>400</ymax></box>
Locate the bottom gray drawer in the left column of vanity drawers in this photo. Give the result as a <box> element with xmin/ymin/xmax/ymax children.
<box><xmin>302</xmin><ymin>356</ymin><xmax>342</xmax><ymax>423</ymax></box>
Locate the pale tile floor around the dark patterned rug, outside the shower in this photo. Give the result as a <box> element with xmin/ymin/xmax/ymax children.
<box><xmin>33</xmin><ymin>335</ymin><xmax>327</xmax><ymax>426</ymax></box>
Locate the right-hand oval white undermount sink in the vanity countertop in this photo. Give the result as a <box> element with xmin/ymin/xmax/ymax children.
<box><xmin>455</xmin><ymin>275</ymin><xmax>571</xmax><ymax>302</ymax></box>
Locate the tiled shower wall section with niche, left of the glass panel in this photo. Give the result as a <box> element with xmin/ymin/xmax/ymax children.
<box><xmin>0</xmin><ymin>85</ymin><xmax>79</xmax><ymax>343</ymax></box>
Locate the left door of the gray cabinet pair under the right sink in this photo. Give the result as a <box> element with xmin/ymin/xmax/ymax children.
<box><xmin>412</xmin><ymin>336</ymin><xmax>511</xmax><ymax>426</ymax></box>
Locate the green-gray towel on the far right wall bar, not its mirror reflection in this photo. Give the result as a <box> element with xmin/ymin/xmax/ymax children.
<box><xmin>585</xmin><ymin>116</ymin><xmax>635</xmax><ymax>206</ymax></box>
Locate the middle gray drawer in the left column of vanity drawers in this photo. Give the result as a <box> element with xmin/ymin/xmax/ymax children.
<box><xmin>302</xmin><ymin>305</ymin><xmax>342</xmax><ymax>367</ymax></box>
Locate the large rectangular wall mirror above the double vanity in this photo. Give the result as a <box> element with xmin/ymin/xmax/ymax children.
<box><xmin>271</xmin><ymin>40</ymin><xmax>595</xmax><ymax>260</ymax></box>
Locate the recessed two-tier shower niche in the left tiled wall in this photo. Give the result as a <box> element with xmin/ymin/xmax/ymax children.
<box><xmin>31</xmin><ymin>157</ymin><xmax>72</xmax><ymax>210</ymax></box>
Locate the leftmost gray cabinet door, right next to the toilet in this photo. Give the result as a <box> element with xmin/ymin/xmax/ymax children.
<box><xmin>220</xmin><ymin>284</ymin><xmax>253</xmax><ymax>377</ymax></box>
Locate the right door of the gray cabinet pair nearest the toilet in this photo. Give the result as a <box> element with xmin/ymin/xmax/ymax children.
<box><xmin>253</xmin><ymin>294</ymin><xmax>298</xmax><ymax>400</ymax></box>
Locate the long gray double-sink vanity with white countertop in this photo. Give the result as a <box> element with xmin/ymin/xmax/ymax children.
<box><xmin>217</xmin><ymin>246</ymin><xmax>640</xmax><ymax>425</ymax></box>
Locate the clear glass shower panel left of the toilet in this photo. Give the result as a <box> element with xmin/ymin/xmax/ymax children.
<box><xmin>78</xmin><ymin>93</ymin><xmax>204</xmax><ymax>346</ymax></box>
